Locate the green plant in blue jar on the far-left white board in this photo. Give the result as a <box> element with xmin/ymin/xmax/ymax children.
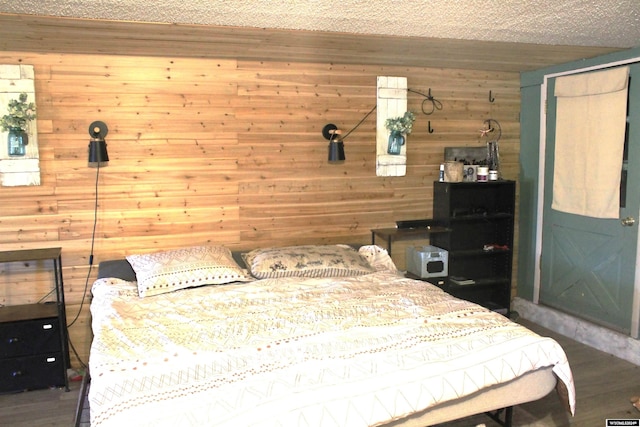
<box><xmin>0</xmin><ymin>92</ymin><xmax>36</xmax><ymax>156</ymax></box>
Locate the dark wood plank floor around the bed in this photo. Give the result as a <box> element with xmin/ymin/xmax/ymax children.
<box><xmin>0</xmin><ymin>320</ymin><xmax>640</xmax><ymax>427</ymax></box>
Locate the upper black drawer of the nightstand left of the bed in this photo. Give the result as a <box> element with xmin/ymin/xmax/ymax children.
<box><xmin>0</xmin><ymin>317</ymin><xmax>62</xmax><ymax>358</ymax></box>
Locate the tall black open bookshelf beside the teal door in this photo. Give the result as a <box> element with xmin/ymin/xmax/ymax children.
<box><xmin>431</xmin><ymin>181</ymin><xmax>515</xmax><ymax>314</ymax></box>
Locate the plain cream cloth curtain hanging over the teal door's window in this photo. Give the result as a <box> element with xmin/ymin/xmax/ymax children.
<box><xmin>551</xmin><ymin>67</ymin><xmax>629</xmax><ymax>218</ymax></box>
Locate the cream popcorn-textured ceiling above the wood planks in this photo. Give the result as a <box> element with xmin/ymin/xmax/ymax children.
<box><xmin>0</xmin><ymin>0</ymin><xmax>640</xmax><ymax>48</ymax></box>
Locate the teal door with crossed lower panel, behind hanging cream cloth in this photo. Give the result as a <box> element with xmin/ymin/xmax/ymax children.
<box><xmin>539</xmin><ymin>64</ymin><xmax>640</xmax><ymax>334</ymax></box>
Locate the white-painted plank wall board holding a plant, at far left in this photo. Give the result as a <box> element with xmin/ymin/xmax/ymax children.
<box><xmin>0</xmin><ymin>65</ymin><xmax>40</xmax><ymax>187</ymax></box>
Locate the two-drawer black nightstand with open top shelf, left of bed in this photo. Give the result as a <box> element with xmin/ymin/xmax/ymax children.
<box><xmin>0</xmin><ymin>248</ymin><xmax>69</xmax><ymax>392</ymax></box>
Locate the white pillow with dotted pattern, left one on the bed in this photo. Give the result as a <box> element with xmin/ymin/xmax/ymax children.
<box><xmin>127</xmin><ymin>246</ymin><xmax>253</xmax><ymax>298</ymax></box>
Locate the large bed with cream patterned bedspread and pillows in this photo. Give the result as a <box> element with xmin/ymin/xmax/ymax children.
<box><xmin>88</xmin><ymin>245</ymin><xmax>575</xmax><ymax>427</ymax></box>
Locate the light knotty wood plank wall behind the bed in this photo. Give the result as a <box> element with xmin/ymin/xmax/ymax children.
<box><xmin>0</xmin><ymin>52</ymin><xmax>520</xmax><ymax>366</ymax></box>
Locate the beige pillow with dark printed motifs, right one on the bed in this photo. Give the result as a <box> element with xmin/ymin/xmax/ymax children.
<box><xmin>242</xmin><ymin>245</ymin><xmax>375</xmax><ymax>279</ymax></box>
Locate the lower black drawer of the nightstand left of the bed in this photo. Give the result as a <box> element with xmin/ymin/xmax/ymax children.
<box><xmin>0</xmin><ymin>352</ymin><xmax>66</xmax><ymax>392</ymax></box>
